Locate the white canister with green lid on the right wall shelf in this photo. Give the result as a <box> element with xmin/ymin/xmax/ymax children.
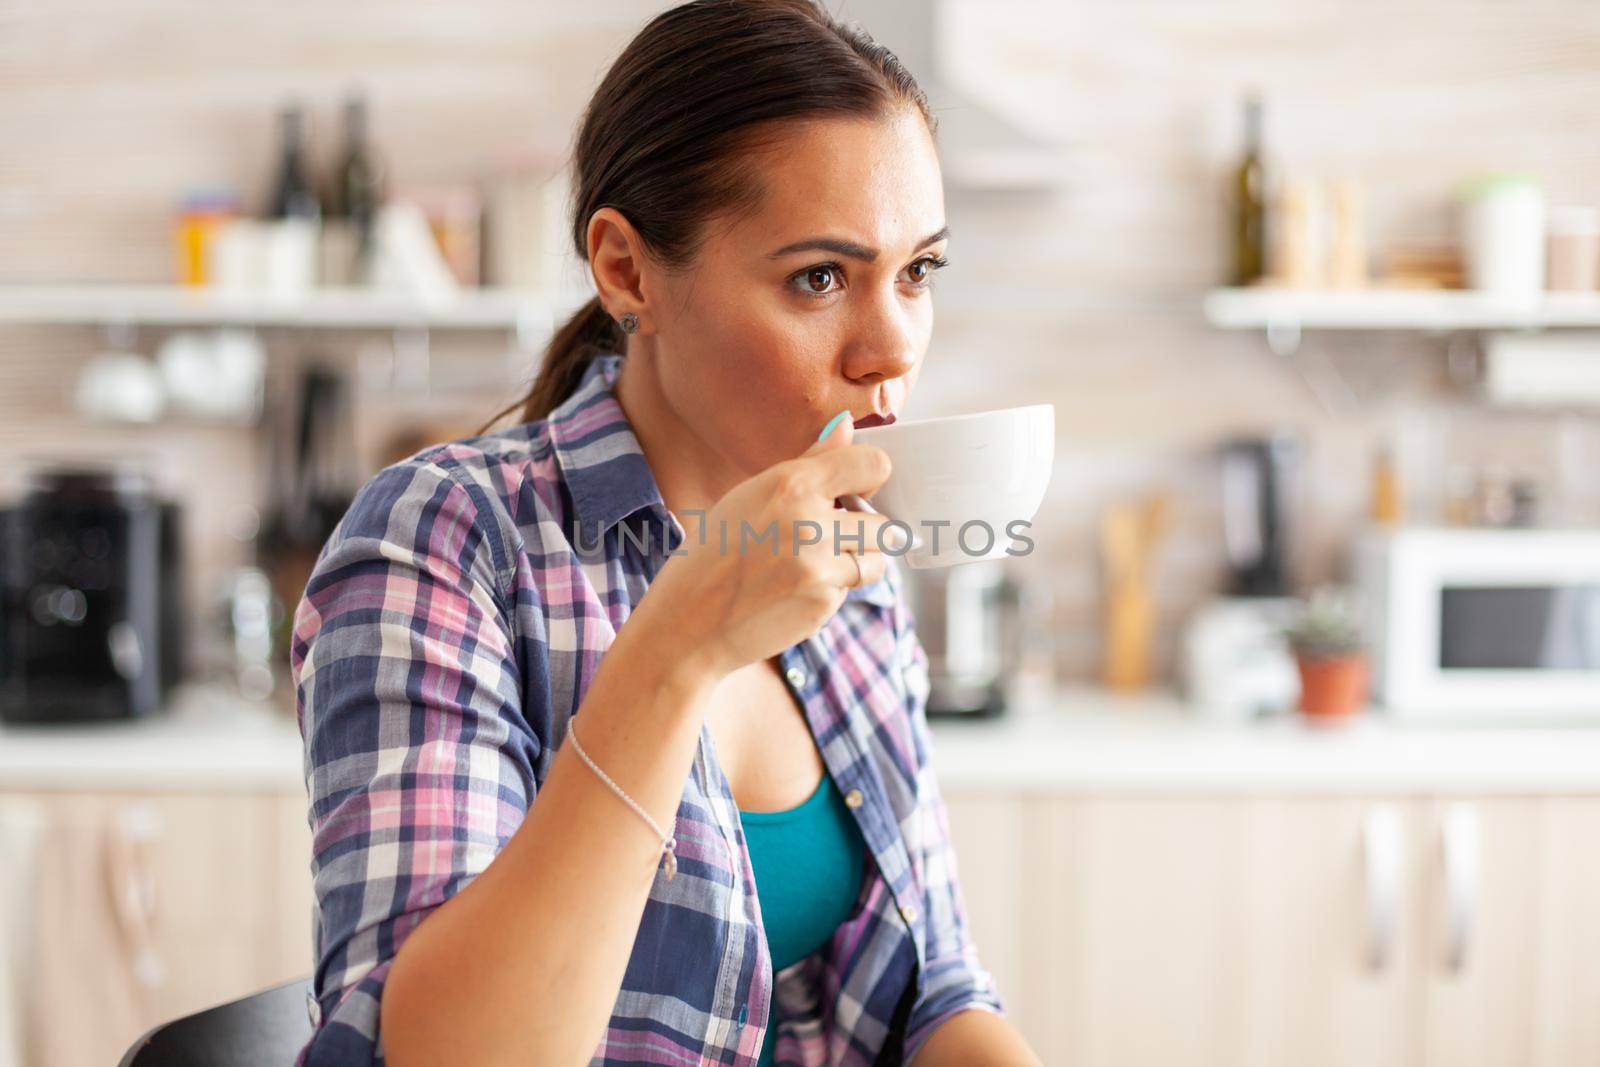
<box><xmin>1464</xmin><ymin>174</ymin><xmax>1544</xmax><ymax>298</ymax></box>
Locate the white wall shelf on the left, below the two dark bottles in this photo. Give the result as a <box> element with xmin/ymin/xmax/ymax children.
<box><xmin>0</xmin><ymin>285</ymin><xmax>589</xmax><ymax>333</ymax></box>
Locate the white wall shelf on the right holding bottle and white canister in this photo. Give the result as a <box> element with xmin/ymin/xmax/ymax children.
<box><xmin>1205</xmin><ymin>288</ymin><xmax>1600</xmax><ymax>333</ymax></box>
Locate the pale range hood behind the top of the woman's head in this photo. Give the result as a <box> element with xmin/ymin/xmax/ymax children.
<box><xmin>834</xmin><ymin>0</ymin><xmax>1066</xmax><ymax>192</ymax></box>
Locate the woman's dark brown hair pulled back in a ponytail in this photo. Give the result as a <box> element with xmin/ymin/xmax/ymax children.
<box><xmin>496</xmin><ymin>0</ymin><xmax>936</xmax><ymax>422</ymax></box>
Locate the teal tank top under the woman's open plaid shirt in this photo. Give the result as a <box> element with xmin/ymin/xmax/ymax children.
<box><xmin>739</xmin><ymin>771</ymin><xmax>866</xmax><ymax>1067</ymax></box>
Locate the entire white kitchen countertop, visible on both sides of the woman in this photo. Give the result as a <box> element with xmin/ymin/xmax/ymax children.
<box><xmin>0</xmin><ymin>686</ymin><xmax>1600</xmax><ymax>793</ymax></box>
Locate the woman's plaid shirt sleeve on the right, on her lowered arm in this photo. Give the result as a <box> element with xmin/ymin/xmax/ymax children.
<box><xmin>896</xmin><ymin>588</ymin><xmax>1005</xmax><ymax>1062</ymax></box>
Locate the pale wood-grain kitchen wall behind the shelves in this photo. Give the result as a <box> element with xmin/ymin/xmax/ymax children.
<box><xmin>0</xmin><ymin>0</ymin><xmax>1600</xmax><ymax>678</ymax></box>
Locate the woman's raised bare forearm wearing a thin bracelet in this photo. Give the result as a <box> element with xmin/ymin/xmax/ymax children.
<box><xmin>379</xmin><ymin>595</ymin><xmax>723</xmax><ymax>1067</ymax></box>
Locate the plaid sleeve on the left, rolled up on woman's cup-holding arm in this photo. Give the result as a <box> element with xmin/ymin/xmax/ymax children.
<box><xmin>290</xmin><ymin>459</ymin><xmax>539</xmax><ymax>1064</ymax></box>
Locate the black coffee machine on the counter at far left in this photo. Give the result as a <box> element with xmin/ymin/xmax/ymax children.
<box><xmin>0</xmin><ymin>467</ymin><xmax>184</xmax><ymax>723</ymax></box>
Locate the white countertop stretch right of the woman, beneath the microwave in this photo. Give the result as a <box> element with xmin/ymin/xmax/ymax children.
<box><xmin>933</xmin><ymin>686</ymin><xmax>1600</xmax><ymax>793</ymax></box>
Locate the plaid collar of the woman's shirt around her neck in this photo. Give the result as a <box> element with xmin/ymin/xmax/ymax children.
<box><xmin>546</xmin><ymin>352</ymin><xmax>898</xmax><ymax>608</ymax></box>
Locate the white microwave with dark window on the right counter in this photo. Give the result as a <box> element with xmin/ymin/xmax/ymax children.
<box><xmin>1354</xmin><ymin>526</ymin><xmax>1600</xmax><ymax>721</ymax></box>
